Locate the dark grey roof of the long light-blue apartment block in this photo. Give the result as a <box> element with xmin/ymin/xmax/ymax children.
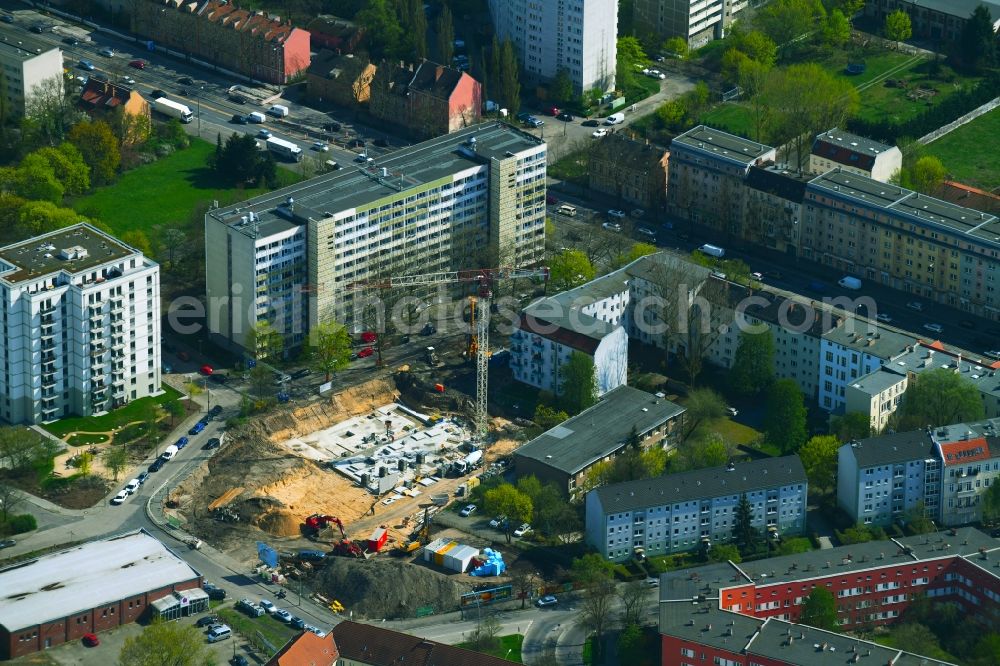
<box><xmin>590</xmin><ymin>455</ymin><xmax>807</xmax><ymax>513</ymax></box>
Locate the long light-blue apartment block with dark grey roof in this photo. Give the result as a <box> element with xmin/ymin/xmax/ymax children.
<box><xmin>585</xmin><ymin>456</ymin><xmax>809</xmax><ymax>562</ymax></box>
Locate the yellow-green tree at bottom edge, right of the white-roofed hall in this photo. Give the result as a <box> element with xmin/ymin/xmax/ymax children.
<box><xmin>118</xmin><ymin>620</ymin><xmax>215</xmax><ymax>666</ymax></box>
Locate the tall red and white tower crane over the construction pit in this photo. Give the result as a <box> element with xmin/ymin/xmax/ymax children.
<box><xmin>346</xmin><ymin>267</ymin><xmax>549</xmax><ymax>442</ymax></box>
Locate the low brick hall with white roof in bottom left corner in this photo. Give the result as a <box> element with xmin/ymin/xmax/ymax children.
<box><xmin>0</xmin><ymin>530</ymin><xmax>202</xmax><ymax>659</ymax></box>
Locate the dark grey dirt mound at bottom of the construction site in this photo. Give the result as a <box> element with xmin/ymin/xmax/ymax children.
<box><xmin>315</xmin><ymin>557</ymin><xmax>469</xmax><ymax>619</ymax></box>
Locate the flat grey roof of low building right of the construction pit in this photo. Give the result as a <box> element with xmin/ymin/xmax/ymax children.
<box><xmin>514</xmin><ymin>386</ymin><xmax>684</xmax><ymax>474</ymax></box>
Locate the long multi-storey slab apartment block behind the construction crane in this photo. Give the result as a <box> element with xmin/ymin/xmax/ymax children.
<box><xmin>205</xmin><ymin>123</ymin><xmax>546</xmax><ymax>348</ymax></box>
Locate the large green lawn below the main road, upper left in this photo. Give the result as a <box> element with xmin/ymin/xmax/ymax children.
<box><xmin>73</xmin><ymin>139</ymin><xmax>300</xmax><ymax>235</ymax></box>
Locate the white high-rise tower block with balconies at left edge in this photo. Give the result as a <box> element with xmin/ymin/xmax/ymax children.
<box><xmin>0</xmin><ymin>224</ymin><xmax>160</xmax><ymax>423</ymax></box>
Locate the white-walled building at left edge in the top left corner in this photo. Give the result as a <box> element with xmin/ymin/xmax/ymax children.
<box><xmin>0</xmin><ymin>25</ymin><xmax>64</xmax><ymax>117</ymax></box>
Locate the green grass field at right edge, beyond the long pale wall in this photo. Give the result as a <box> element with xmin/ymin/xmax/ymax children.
<box><xmin>927</xmin><ymin>109</ymin><xmax>1000</xmax><ymax>190</ymax></box>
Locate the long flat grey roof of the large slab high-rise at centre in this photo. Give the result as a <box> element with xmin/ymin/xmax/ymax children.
<box><xmin>208</xmin><ymin>122</ymin><xmax>544</xmax><ymax>234</ymax></box>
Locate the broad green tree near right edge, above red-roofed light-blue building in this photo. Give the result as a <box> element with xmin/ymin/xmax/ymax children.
<box><xmin>893</xmin><ymin>368</ymin><xmax>985</xmax><ymax>432</ymax></box>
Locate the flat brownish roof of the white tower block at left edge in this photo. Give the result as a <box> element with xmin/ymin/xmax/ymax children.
<box><xmin>0</xmin><ymin>223</ymin><xmax>138</xmax><ymax>284</ymax></box>
